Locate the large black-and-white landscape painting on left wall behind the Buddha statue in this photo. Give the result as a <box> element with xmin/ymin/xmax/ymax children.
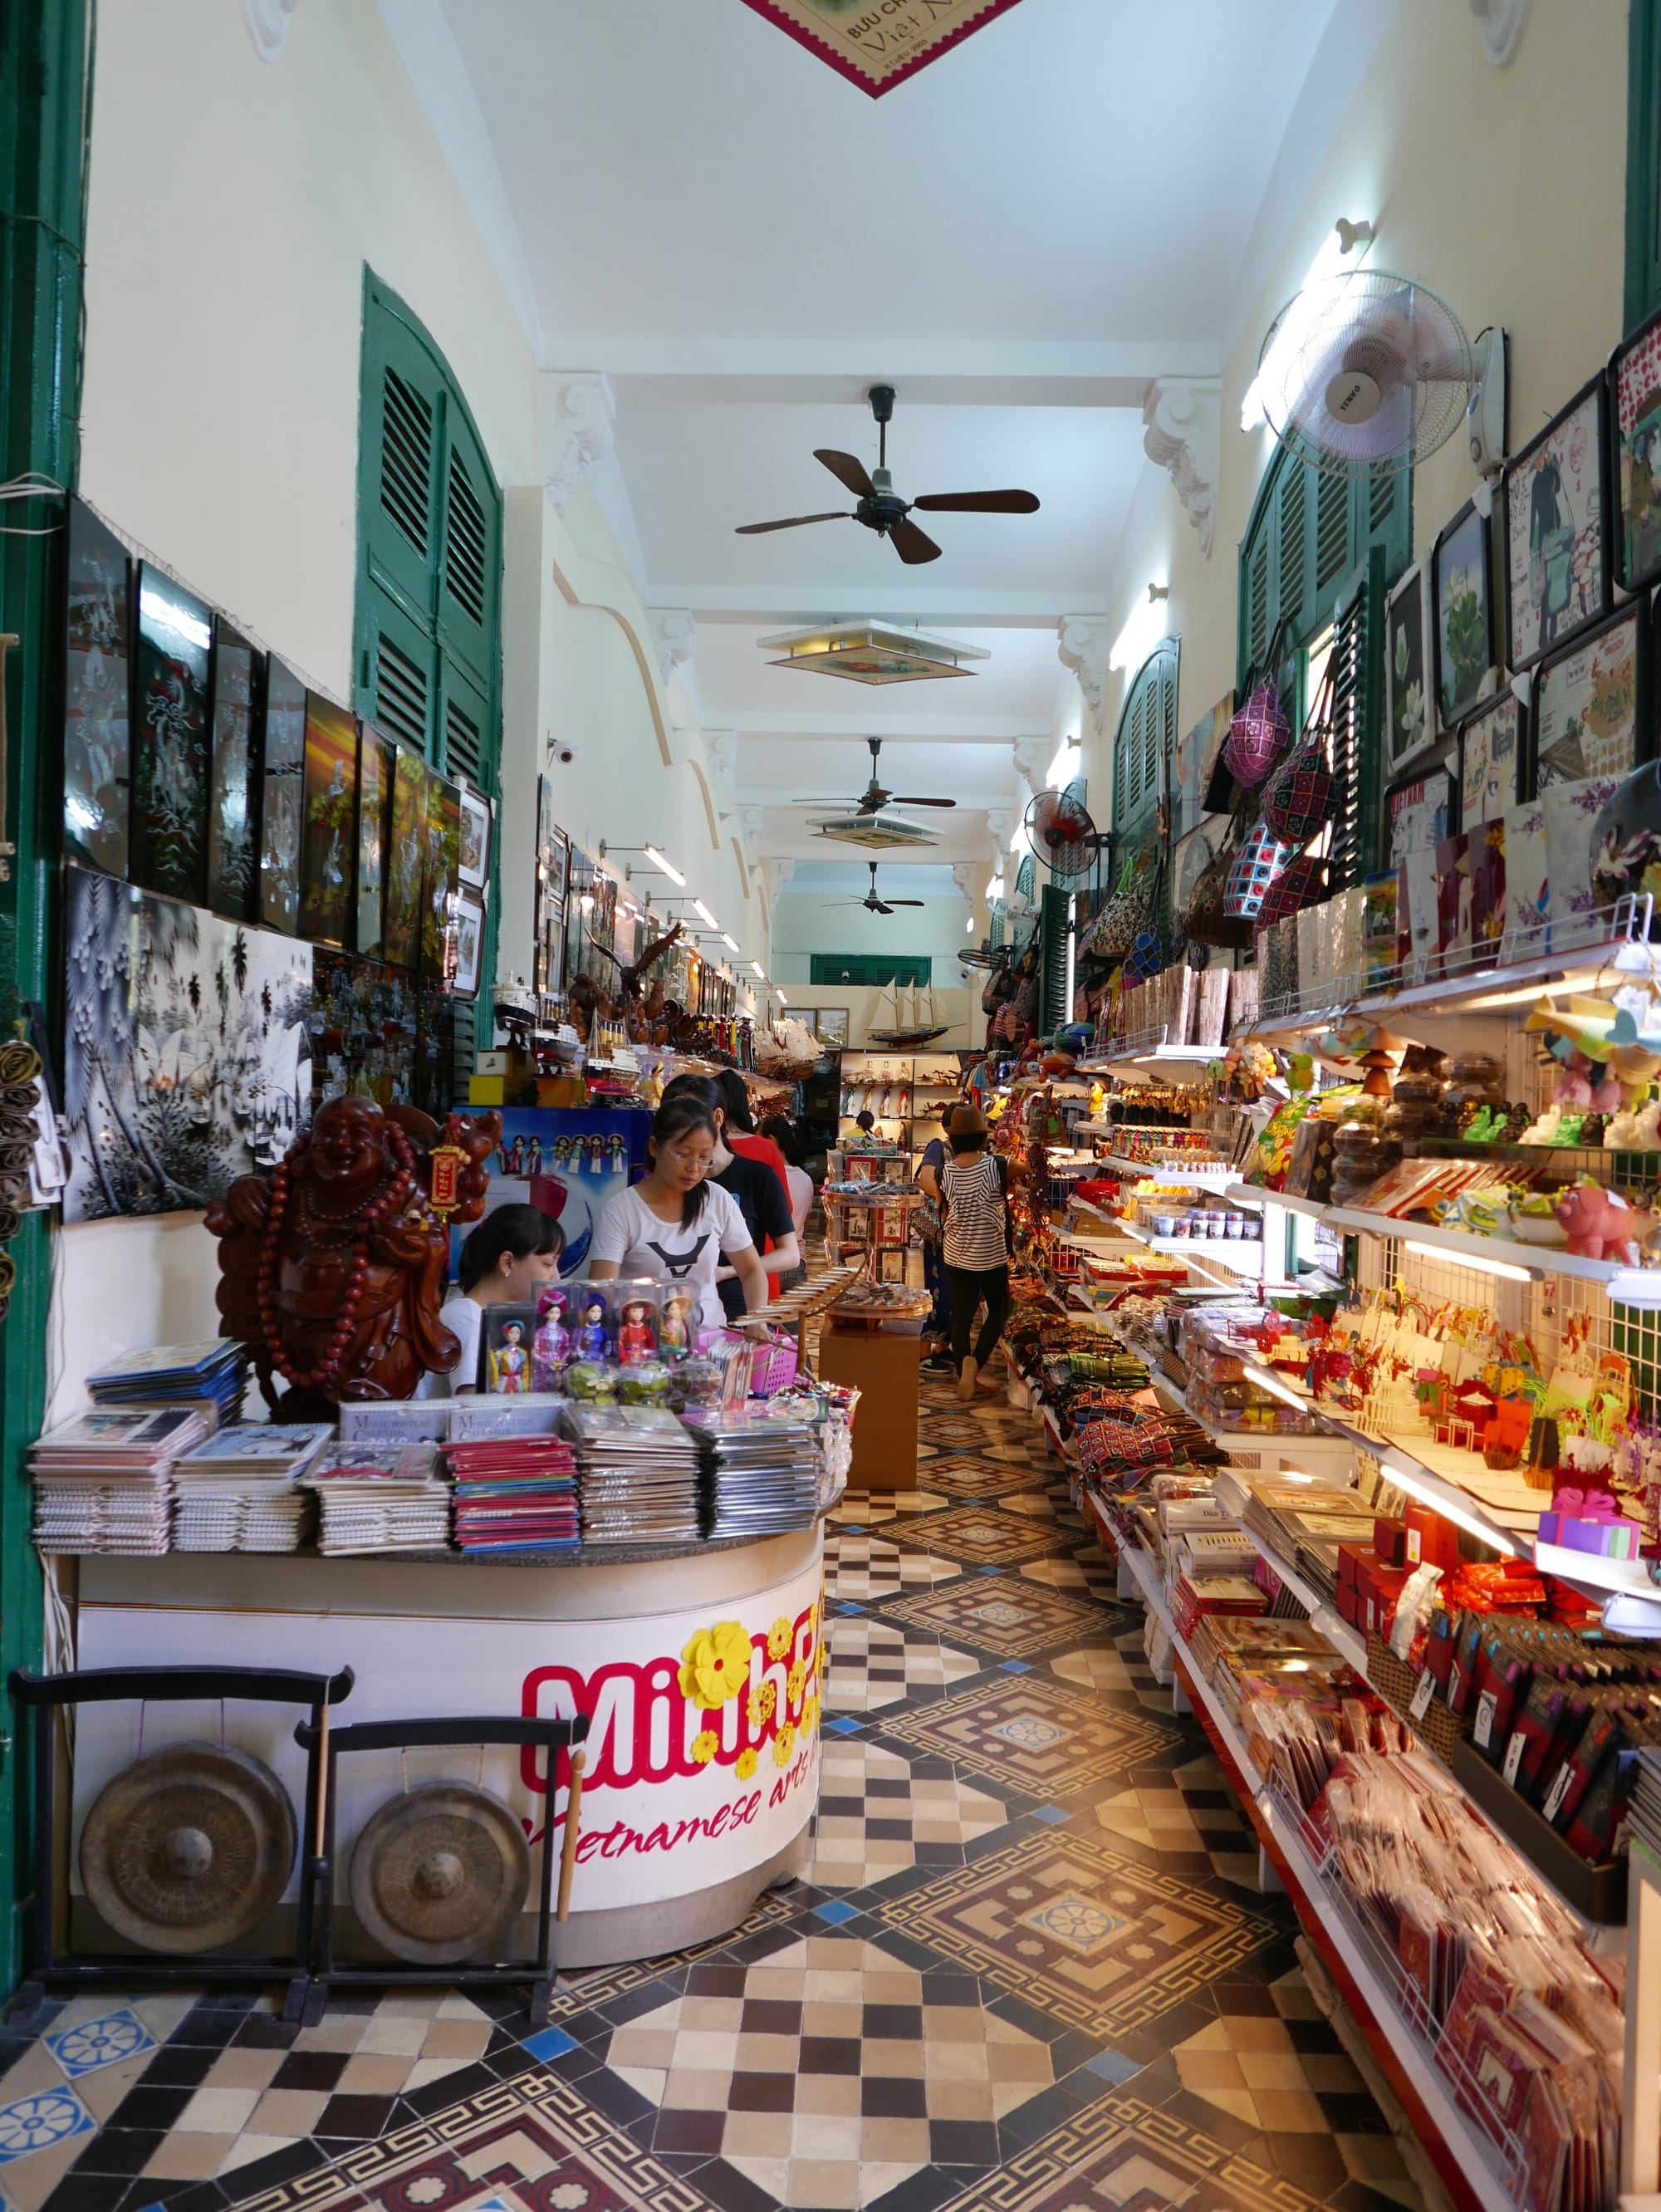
<box><xmin>64</xmin><ymin>867</ymin><xmax>311</xmax><ymax>1221</ymax></box>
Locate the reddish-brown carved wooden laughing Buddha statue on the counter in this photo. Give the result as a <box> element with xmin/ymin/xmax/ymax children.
<box><xmin>208</xmin><ymin>1097</ymin><xmax>502</xmax><ymax>1420</ymax></box>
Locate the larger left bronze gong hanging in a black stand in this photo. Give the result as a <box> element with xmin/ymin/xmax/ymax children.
<box><xmin>80</xmin><ymin>1743</ymin><xmax>299</xmax><ymax>1951</ymax></box>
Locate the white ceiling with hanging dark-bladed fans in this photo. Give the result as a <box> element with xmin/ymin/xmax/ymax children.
<box><xmin>409</xmin><ymin>0</ymin><xmax>1353</xmax><ymax>890</ymax></box>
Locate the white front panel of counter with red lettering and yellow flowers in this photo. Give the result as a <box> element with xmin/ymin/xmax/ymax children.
<box><xmin>71</xmin><ymin>1562</ymin><xmax>823</xmax><ymax>1913</ymax></box>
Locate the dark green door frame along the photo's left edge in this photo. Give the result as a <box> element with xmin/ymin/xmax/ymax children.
<box><xmin>0</xmin><ymin>0</ymin><xmax>91</xmax><ymax>1989</ymax></box>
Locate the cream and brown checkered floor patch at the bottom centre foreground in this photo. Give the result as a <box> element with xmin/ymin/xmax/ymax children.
<box><xmin>608</xmin><ymin>1935</ymin><xmax>1051</xmax><ymax>2208</ymax></box>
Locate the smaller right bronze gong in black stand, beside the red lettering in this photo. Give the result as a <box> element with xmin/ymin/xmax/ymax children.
<box><xmin>351</xmin><ymin>1783</ymin><xmax>531</xmax><ymax>1966</ymax></box>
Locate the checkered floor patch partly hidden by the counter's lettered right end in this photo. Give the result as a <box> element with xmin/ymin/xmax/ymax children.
<box><xmin>807</xmin><ymin>1736</ymin><xmax>1008</xmax><ymax>1889</ymax></box>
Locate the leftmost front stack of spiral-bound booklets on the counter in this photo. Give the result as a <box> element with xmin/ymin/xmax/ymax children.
<box><xmin>29</xmin><ymin>1405</ymin><xmax>210</xmax><ymax>1555</ymax></box>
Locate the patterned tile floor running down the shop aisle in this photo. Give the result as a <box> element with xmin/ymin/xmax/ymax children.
<box><xmin>0</xmin><ymin>1381</ymin><xmax>1422</xmax><ymax>2212</ymax></box>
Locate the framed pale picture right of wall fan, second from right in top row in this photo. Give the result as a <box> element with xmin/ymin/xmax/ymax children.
<box><xmin>1502</xmin><ymin>376</ymin><xmax>1610</xmax><ymax>673</ymax></box>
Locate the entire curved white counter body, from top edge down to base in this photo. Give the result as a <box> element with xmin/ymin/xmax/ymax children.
<box><xmin>71</xmin><ymin>1522</ymin><xmax>823</xmax><ymax>1969</ymax></box>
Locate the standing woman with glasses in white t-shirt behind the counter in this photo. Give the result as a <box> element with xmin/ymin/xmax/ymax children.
<box><xmin>588</xmin><ymin>1095</ymin><xmax>767</xmax><ymax>1329</ymax></box>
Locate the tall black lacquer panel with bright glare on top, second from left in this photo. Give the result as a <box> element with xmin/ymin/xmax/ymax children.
<box><xmin>128</xmin><ymin>562</ymin><xmax>213</xmax><ymax>907</ymax></box>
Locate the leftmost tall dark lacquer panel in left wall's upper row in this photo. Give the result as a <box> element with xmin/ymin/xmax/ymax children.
<box><xmin>64</xmin><ymin>500</ymin><xmax>133</xmax><ymax>876</ymax></box>
